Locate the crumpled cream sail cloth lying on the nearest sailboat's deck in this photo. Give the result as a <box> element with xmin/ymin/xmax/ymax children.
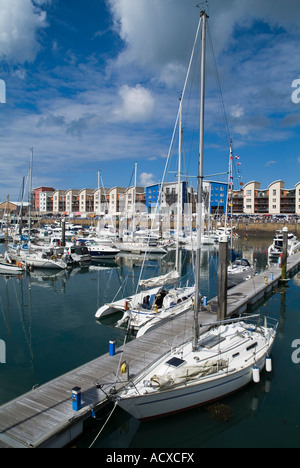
<box><xmin>150</xmin><ymin>359</ymin><xmax>228</xmax><ymax>390</ymax></box>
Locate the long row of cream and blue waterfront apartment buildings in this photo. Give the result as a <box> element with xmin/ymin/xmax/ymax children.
<box><xmin>0</xmin><ymin>180</ymin><xmax>300</xmax><ymax>217</ymax></box>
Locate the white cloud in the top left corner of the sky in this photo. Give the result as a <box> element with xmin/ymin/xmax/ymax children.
<box><xmin>0</xmin><ymin>0</ymin><xmax>46</xmax><ymax>64</ymax></box>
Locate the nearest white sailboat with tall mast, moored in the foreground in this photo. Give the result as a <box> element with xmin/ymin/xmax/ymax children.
<box><xmin>116</xmin><ymin>11</ymin><xmax>278</xmax><ymax>420</ymax></box>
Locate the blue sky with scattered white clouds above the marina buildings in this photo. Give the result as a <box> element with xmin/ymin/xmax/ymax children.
<box><xmin>0</xmin><ymin>0</ymin><xmax>300</xmax><ymax>201</ymax></box>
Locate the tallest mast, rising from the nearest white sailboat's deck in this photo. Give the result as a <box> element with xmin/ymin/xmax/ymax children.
<box><xmin>193</xmin><ymin>10</ymin><xmax>208</xmax><ymax>350</ymax></box>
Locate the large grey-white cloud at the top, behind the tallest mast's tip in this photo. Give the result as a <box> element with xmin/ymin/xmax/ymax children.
<box><xmin>107</xmin><ymin>0</ymin><xmax>300</xmax><ymax>84</ymax></box>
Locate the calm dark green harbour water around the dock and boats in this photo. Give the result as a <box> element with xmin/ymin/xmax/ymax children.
<box><xmin>0</xmin><ymin>236</ymin><xmax>300</xmax><ymax>449</ymax></box>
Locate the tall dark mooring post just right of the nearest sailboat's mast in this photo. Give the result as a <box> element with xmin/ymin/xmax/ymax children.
<box><xmin>218</xmin><ymin>236</ymin><xmax>228</xmax><ymax>320</ymax></box>
